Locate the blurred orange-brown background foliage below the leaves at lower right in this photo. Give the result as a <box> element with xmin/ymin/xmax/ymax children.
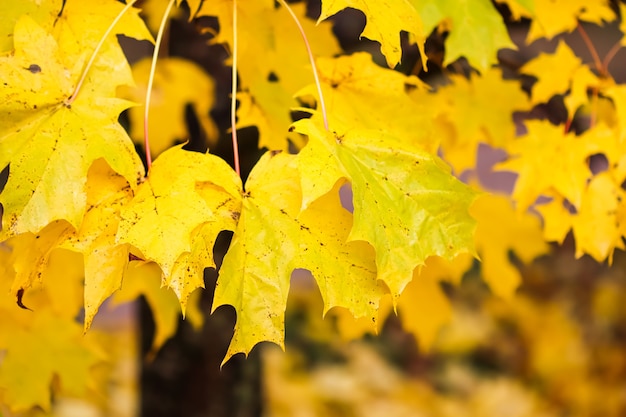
<box><xmin>262</xmin><ymin>242</ymin><xmax>626</xmax><ymax>417</ymax></box>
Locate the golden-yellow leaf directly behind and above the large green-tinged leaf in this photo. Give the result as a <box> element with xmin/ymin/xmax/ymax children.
<box><xmin>298</xmin><ymin>52</ymin><xmax>439</xmax><ymax>159</ymax></box>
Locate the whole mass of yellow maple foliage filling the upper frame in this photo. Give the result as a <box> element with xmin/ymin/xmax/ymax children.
<box><xmin>0</xmin><ymin>0</ymin><xmax>626</xmax><ymax>412</ymax></box>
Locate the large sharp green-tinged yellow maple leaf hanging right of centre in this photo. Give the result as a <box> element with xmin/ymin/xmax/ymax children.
<box><xmin>294</xmin><ymin>119</ymin><xmax>476</xmax><ymax>299</ymax></box>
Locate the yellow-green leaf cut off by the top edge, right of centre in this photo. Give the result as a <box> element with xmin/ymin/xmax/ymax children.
<box><xmin>408</xmin><ymin>0</ymin><xmax>515</xmax><ymax>71</ymax></box>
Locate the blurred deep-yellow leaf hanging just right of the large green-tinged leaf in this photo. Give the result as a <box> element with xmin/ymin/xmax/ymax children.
<box><xmin>470</xmin><ymin>194</ymin><xmax>549</xmax><ymax>299</ymax></box>
